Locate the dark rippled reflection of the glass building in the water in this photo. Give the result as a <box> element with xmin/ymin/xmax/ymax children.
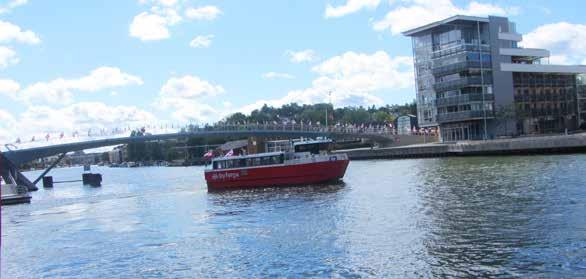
<box><xmin>417</xmin><ymin>156</ymin><xmax>584</xmax><ymax>277</ymax></box>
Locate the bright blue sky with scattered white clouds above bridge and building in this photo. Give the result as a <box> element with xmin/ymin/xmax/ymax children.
<box><xmin>0</xmin><ymin>0</ymin><xmax>586</xmax><ymax>147</ymax></box>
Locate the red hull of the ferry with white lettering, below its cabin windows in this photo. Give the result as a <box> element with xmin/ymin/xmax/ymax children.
<box><xmin>205</xmin><ymin>160</ymin><xmax>349</xmax><ymax>190</ymax></box>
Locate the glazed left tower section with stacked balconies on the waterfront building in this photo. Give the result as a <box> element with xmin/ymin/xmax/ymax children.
<box><xmin>413</xmin><ymin>21</ymin><xmax>494</xmax><ymax>140</ymax></box>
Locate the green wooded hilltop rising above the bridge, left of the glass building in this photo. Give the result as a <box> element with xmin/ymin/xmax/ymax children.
<box><xmin>223</xmin><ymin>101</ymin><xmax>417</xmax><ymax>125</ymax></box>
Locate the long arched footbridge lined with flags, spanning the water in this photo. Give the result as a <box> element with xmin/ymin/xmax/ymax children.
<box><xmin>0</xmin><ymin>124</ymin><xmax>398</xmax><ymax>191</ymax></box>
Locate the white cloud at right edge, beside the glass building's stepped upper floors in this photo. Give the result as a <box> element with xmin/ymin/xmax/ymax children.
<box><xmin>521</xmin><ymin>22</ymin><xmax>586</xmax><ymax>64</ymax></box>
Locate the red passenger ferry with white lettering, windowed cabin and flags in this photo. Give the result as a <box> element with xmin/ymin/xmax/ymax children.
<box><xmin>205</xmin><ymin>140</ymin><xmax>349</xmax><ymax>190</ymax></box>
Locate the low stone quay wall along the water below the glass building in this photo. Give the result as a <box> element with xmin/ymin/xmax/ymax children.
<box><xmin>336</xmin><ymin>133</ymin><xmax>586</xmax><ymax>160</ymax></box>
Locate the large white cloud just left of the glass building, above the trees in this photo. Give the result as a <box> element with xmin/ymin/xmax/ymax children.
<box><xmin>236</xmin><ymin>51</ymin><xmax>413</xmax><ymax>113</ymax></box>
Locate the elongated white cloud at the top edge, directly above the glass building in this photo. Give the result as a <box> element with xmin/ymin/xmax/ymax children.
<box><xmin>372</xmin><ymin>0</ymin><xmax>518</xmax><ymax>35</ymax></box>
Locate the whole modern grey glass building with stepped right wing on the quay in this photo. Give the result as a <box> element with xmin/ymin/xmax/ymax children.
<box><xmin>403</xmin><ymin>15</ymin><xmax>586</xmax><ymax>141</ymax></box>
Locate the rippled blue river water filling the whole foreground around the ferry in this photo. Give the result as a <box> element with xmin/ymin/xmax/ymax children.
<box><xmin>1</xmin><ymin>155</ymin><xmax>586</xmax><ymax>278</ymax></box>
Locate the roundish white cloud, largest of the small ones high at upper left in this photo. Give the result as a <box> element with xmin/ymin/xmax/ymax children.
<box><xmin>130</xmin><ymin>12</ymin><xmax>170</xmax><ymax>41</ymax></box>
